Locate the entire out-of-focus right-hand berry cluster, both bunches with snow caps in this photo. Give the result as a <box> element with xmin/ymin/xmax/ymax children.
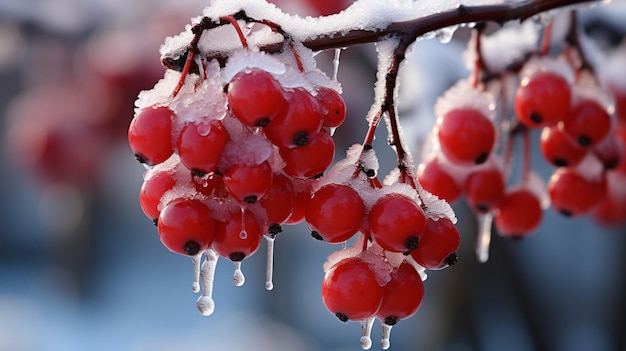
<box><xmin>417</xmin><ymin>56</ymin><xmax>626</xmax><ymax>245</ymax></box>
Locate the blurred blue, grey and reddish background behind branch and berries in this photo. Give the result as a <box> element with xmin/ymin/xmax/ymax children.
<box><xmin>0</xmin><ymin>0</ymin><xmax>626</xmax><ymax>351</ymax></box>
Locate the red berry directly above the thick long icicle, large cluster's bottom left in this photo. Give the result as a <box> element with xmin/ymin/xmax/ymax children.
<box><xmin>157</xmin><ymin>199</ymin><xmax>215</xmax><ymax>256</ymax></box>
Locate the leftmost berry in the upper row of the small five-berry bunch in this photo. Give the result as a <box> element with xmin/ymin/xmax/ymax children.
<box><xmin>306</xmin><ymin>184</ymin><xmax>365</xmax><ymax>243</ymax></box>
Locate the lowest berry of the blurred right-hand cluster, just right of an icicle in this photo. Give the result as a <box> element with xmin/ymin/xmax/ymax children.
<box><xmin>494</xmin><ymin>188</ymin><xmax>543</xmax><ymax>238</ymax></box>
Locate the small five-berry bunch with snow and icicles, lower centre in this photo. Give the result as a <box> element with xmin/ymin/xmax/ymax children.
<box><xmin>305</xmin><ymin>144</ymin><xmax>460</xmax><ymax>349</ymax></box>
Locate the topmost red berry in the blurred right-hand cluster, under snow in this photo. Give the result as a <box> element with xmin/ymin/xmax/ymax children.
<box><xmin>515</xmin><ymin>72</ymin><xmax>572</xmax><ymax>128</ymax></box>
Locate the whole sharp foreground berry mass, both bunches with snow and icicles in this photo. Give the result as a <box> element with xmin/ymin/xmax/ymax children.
<box><xmin>128</xmin><ymin>26</ymin><xmax>460</xmax><ymax>348</ymax></box>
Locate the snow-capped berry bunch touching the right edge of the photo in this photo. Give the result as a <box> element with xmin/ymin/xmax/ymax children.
<box><xmin>515</xmin><ymin>58</ymin><xmax>626</xmax><ymax>223</ymax></box>
